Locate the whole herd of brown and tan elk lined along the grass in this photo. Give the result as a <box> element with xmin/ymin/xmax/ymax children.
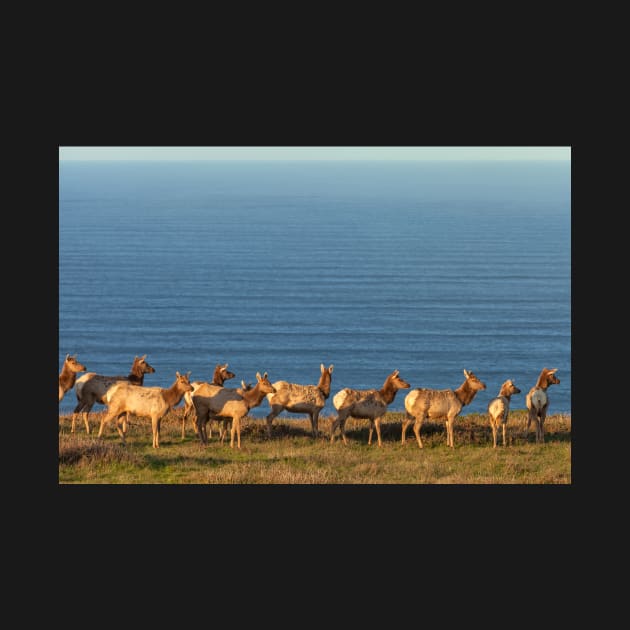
<box><xmin>59</xmin><ymin>354</ymin><xmax>560</xmax><ymax>448</ymax></box>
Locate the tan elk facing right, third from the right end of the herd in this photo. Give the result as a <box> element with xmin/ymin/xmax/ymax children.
<box><xmin>401</xmin><ymin>370</ymin><xmax>486</xmax><ymax>448</ymax></box>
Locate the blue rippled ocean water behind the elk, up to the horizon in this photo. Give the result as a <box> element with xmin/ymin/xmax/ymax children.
<box><xmin>59</xmin><ymin>161</ymin><xmax>571</xmax><ymax>418</ymax></box>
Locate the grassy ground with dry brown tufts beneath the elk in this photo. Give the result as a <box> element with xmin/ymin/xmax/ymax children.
<box><xmin>59</xmin><ymin>409</ymin><xmax>571</xmax><ymax>484</ymax></box>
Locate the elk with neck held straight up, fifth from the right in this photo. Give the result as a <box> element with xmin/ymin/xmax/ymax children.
<box><xmin>267</xmin><ymin>363</ymin><xmax>333</xmax><ymax>437</ymax></box>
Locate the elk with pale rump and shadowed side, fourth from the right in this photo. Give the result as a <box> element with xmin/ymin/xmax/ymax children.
<box><xmin>330</xmin><ymin>370</ymin><xmax>410</xmax><ymax>446</ymax></box>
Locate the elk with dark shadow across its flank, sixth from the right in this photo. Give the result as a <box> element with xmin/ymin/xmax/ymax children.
<box><xmin>192</xmin><ymin>372</ymin><xmax>276</xmax><ymax>448</ymax></box>
